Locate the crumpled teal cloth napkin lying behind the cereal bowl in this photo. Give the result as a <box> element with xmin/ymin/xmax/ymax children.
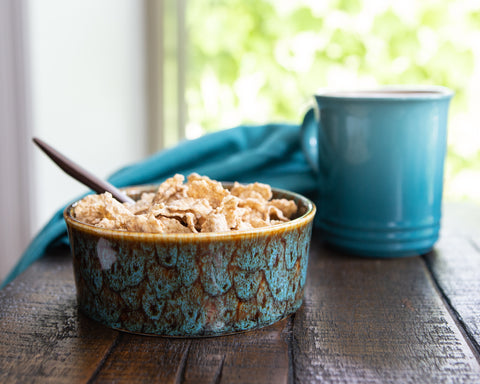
<box><xmin>2</xmin><ymin>124</ymin><xmax>315</xmax><ymax>287</ymax></box>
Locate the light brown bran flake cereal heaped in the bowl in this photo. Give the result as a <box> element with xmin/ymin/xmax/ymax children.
<box><xmin>74</xmin><ymin>173</ymin><xmax>297</xmax><ymax>233</ymax></box>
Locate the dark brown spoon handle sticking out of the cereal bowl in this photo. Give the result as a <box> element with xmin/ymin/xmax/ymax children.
<box><xmin>33</xmin><ymin>137</ymin><xmax>134</xmax><ymax>203</ymax></box>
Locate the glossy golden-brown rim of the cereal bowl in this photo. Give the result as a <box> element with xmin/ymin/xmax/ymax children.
<box><xmin>63</xmin><ymin>182</ymin><xmax>316</xmax><ymax>240</ymax></box>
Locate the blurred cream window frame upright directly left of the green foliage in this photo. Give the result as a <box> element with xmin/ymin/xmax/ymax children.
<box><xmin>145</xmin><ymin>0</ymin><xmax>188</xmax><ymax>153</ymax></box>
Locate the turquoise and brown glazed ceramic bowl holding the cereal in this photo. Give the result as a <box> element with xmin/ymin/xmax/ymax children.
<box><xmin>64</xmin><ymin>186</ymin><xmax>315</xmax><ymax>337</ymax></box>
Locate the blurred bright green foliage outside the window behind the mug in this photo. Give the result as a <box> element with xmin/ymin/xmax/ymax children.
<box><xmin>186</xmin><ymin>0</ymin><xmax>480</xmax><ymax>201</ymax></box>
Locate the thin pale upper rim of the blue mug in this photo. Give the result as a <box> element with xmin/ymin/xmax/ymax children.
<box><xmin>314</xmin><ymin>85</ymin><xmax>454</xmax><ymax>100</ymax></box>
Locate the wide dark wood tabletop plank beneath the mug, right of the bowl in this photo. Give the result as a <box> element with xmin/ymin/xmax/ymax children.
<box><xmin>293</xmin><ymin>236</ymin><xmax>480</xmax><ymax>383</ymax></box>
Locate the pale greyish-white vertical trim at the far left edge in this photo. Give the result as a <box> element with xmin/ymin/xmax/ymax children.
<box><xmin>0</xmin><ymin>0</ymin><xmax>32</xmax><ymax>281</ymax></box>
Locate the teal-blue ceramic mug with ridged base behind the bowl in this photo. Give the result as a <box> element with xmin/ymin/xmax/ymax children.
<box><xmin>302</xmin><ymin>87</ymin><xmax>453</xmax><ymax>257</ymax></box>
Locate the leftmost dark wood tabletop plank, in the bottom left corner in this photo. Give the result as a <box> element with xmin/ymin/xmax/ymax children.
<box><xmin>0</xmin><ymin>249</ymin><xmax>118</xmax><ymax>383</ymax></box>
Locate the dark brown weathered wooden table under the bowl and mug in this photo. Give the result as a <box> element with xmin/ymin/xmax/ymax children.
<box><xmin>0</xmin><ymin>205</ymin><xmax>480</xmax><ymax>384</ymax></box>
